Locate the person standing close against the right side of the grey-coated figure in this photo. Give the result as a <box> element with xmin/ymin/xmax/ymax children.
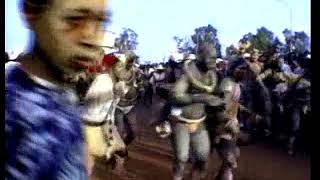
<box><xmin>208</xmin><ymin>77</ymin><xmax>241</xmax><ymax>180</ymax></box>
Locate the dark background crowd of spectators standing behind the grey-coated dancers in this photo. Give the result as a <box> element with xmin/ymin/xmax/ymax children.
<box><xmin>136</xmin><ymin>43</ymin><xmax>311</xmax><ymax>158</ymax></box>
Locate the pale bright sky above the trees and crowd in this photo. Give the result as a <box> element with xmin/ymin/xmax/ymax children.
<box><xmin>5</xmin><ymin>0</ymin><xmax>311</xmax><ymax>61</ymax></box>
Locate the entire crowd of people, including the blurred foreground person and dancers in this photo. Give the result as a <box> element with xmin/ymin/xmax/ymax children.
<box><xmin>5</xmin><ymin>0</ymin><xmax>311</xmax><ymax>180</ymax></box>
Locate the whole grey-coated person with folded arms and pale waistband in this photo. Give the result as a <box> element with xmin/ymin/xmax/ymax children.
<box><xmin>169</xmin><ymin>40</ymin><xmax>229</xmax><ymax>179</ymax></box>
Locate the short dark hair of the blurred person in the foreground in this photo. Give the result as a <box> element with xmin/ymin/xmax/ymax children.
<box><xmin>20</xmin><ymin>0</ymin><xmax>53</xmax><ymax>14</ymax></box>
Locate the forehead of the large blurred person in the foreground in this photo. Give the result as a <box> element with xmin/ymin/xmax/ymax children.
<box><xmin>53</xmin><ymin>0</ymin><xmax>109</xmax><ymax>14</ymax></box>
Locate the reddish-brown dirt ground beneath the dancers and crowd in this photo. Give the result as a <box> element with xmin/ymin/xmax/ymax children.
<box><xmin>91</xmin><ymin>98</ymin><xmax>310</xmax><ymax>180</ymax></box>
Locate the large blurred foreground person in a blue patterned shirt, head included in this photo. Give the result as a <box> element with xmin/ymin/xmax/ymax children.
<box><xmin>5</xmin><ymin>0</ymin><xmax>107</xmax><ymax>180</ymax></box>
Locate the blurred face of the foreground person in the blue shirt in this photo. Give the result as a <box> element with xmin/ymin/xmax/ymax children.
<box><xmin>31</xmin><ymin>0</ymin><xmax>108</xmax><ymax>75</ymax></box>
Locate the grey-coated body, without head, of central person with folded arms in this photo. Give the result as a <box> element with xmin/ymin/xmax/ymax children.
<box><xmin>170</xmin><ymin>58</ymin><xmax>219</xmax><ymax>179</ymax></box>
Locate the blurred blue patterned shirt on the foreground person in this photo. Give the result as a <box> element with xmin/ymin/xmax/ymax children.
<box><xmin>5</xmin><ymin>64</ymin><xmax>87</xmax><ymax>180</ymax></box>
